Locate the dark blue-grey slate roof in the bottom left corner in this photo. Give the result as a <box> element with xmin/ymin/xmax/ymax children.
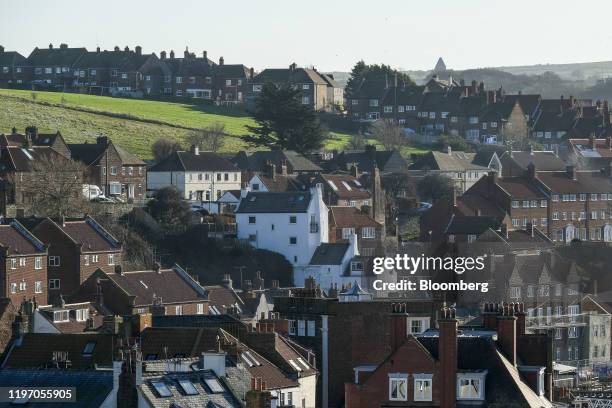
<box><xmin>0</xmin><ymin>368</ymin><xmax>113</xmax><ymax>408</ymax></box>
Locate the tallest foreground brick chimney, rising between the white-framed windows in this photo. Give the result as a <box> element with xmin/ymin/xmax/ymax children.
<box><xmin>438</xmin><ymin>307</ymin><xmax>457</xmax><ymax>408</ymax></box>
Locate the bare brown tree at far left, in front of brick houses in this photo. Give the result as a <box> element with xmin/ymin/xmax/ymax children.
<box><xmin>10</xmin><ymin>154</ymin><xmax>89</xmax><ymax>217</ymax></box>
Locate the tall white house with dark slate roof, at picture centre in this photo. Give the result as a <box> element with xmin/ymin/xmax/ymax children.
<box><xmin>236</xmin><ymin>186</ymin><xmax>329</xmax><ymax>274</ymax></box>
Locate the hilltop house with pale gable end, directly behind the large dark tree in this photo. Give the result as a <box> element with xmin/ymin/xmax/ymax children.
<box><xmin>247</xmin><ymin>63</ymin><xmax>333</xmax><ymax>111</ymax></box>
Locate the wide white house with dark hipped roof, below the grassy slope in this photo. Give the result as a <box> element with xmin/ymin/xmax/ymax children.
<box><xmin>147</xmin><ymin>146</ymin><xmax>242</xmax><ymax>202</ymax></box>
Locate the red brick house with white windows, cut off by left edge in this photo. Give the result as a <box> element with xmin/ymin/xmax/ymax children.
<box><xmin>0</xmin><ymin>220</ymin><xmax>47</xmax><ymax>305</ymax></box>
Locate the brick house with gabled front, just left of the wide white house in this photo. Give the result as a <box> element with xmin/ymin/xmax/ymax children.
<box><xmin>68</xmin><ymin>136</ymin><xmax>147</xmax><ymax>201</ymax></box>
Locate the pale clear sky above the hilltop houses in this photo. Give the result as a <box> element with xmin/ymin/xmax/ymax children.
<box><xmin>0</xmin><ymin>0</ymin><xmax>612</xmax><ymax>71</ymax></box>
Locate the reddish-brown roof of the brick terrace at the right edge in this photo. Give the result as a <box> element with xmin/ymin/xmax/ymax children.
<box><xmin>537</xmin><ymin>171</ymin><xmax>612</xmax><ymax>193</ymax></box>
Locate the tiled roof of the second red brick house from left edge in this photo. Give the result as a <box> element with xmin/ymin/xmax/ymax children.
<box><xmin>32</xmin><ymin>216</ymin><xmax>121</xmax><ymax>252</ymax></box>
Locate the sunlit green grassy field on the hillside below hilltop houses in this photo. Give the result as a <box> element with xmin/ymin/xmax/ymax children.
<box><xmin>0</xmin><ymin>89</ymin><xmax>422</xmax><ymax>159</ymax></box>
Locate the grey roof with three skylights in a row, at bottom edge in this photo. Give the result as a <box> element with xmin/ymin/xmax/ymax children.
<box><xmin>138</xmin><ymin>370</ymin><xmax>242</xmax><ymax>408</ymax></box>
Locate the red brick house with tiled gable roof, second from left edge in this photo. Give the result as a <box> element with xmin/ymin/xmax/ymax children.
<box><xmin>32</xmin><ymin>216</ymin><xmax>122</xmax><ymax>299</ymax></box>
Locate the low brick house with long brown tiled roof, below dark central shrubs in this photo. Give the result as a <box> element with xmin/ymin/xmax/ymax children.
<box><xmin>74</xmin><ymin>265</ymin><xmax>208</xmax><ymax>316</ymax></box>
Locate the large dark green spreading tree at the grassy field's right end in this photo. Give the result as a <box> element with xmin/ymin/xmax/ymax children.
<box><xmin>242</xmin><ymin>84</ymin><xmax>325</xmax><ymax>153</ymax></box>
